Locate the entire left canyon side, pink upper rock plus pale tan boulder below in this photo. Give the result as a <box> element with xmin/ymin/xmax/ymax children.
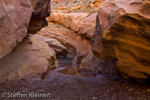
<box><xmin>0</xmin><ymin>0</ymin><xmax>56</xmax><ymax>82</ymax></box>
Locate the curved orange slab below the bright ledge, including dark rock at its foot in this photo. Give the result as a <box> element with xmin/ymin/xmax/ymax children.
<box><xmin>38</xmin><ymin>22</ymin><xmax>118</xmax><ymax>76</ymax></box>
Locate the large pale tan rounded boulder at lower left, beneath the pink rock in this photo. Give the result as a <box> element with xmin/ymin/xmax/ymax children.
<box><xmin>0</xmin><ymin>35</ymin><xmax>56</xmax><ymax>82</ymax></box>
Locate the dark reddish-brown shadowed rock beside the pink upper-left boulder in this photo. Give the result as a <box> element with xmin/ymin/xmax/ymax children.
<box><xmin>28</xmin><ymin>0</ymin><xmax>51</xmax><ymax>34</ymax></box>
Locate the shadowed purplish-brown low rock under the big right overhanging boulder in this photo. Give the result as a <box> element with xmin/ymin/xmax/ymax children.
<box><xmin>79</xmin><ymin>51</ymin><xmax>120</xmax><ymax>76</ymax></box>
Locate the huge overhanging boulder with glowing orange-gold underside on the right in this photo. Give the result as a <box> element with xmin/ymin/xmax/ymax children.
<box><xmin>92</xmin><ymin>0</ymin><xmax>150</xmax><ymax>78</ymax></box>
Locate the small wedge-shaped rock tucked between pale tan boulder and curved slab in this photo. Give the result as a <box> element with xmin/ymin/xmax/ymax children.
<box><xmin>38</xmin><ymin>35</ymin><xmax>68</xmax><ymax>56</ymax></box>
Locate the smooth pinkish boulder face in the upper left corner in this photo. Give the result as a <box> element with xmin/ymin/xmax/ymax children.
<box><xmin>0</xmin><ymin>0</ymin><xmax>32</xmax><ymax>58</ymax></box>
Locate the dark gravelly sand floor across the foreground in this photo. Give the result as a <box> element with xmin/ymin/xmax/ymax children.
<box><xmin>0</xmin><ymin>57</ymin><xmax>150</xmax><ymax>100</ymax></box>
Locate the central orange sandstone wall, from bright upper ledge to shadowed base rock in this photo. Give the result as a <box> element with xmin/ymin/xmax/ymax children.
<box><xmin>41</xmin><ymin>9</ymin><xmax>119</xmax><ymax>76</ymax></box>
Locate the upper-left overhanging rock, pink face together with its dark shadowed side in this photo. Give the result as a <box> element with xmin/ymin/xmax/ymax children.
<box><xmin>0</xmin><ymin>0</ymin><xmax>50</xmax><ymax>58</ymax></box>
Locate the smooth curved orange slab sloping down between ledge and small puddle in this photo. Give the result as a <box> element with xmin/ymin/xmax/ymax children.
<box><xmin>38</xmin><ymin>22</ymin><xmax>91</xmax><ymax>63</ymax></box>
